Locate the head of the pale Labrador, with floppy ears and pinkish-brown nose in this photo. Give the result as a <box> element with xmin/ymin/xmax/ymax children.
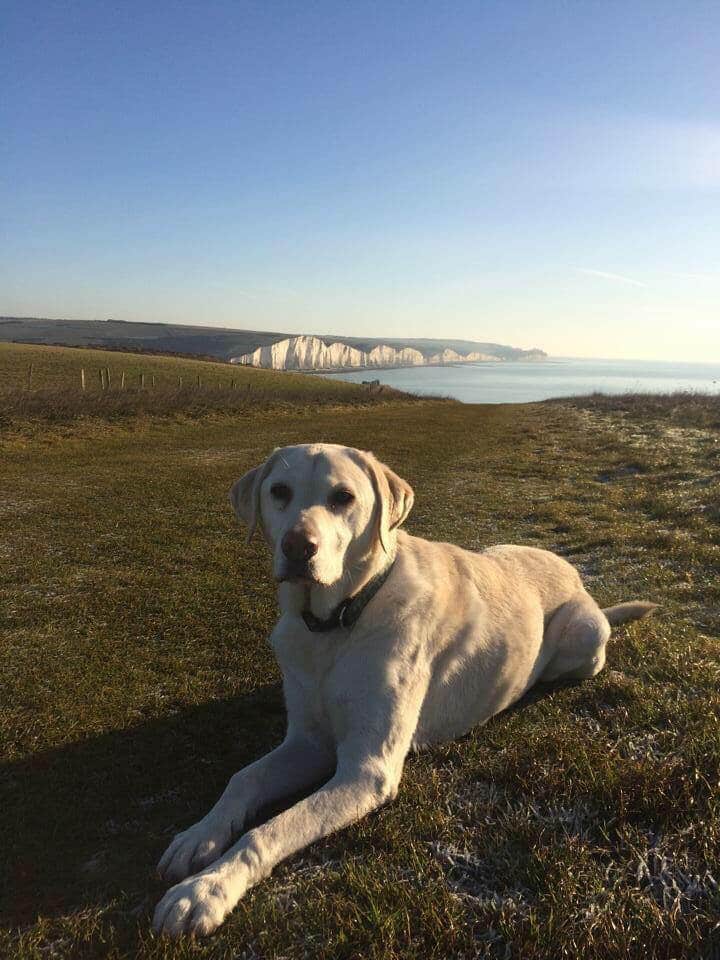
<box><xmin>230</xmin><ymin>443</ymin><xmax>414</xmax><ymax>586</ymax></box>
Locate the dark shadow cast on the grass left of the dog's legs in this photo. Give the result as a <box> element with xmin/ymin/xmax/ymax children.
<box><xmin>0</xmin><ymin>684</ymin><xmax>285</xmax><ymax>927</ymax></box>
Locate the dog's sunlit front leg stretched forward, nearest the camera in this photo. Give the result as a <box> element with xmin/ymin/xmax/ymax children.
<box><xmin>153</xmin><ymin>691</ymin><xmax>420</xmax><ymax>936</ymax></box>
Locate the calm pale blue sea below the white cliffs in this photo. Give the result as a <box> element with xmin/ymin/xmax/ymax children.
<box><xmin>320</xmin><ymin>359</ymin><xmax>720</xmax><ymax>403</ymax></box>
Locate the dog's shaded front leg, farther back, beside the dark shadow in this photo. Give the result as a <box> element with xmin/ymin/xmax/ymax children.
<box><xmin>157</xmin><ymin>736</ymin><xmax>335</xmax><ymax>882</ymax></box>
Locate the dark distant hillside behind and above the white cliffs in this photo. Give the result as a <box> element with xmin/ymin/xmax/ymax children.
<box><xmin>0</xmin><ymin>317</ymin><xmax>545</xmax><ymax>361</ymax></box>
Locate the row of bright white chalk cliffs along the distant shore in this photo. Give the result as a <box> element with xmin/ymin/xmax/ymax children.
<box><xmin>230</xmin><ymin>335</ymin><xmax>499</xmax><ymax>370</ymax></box>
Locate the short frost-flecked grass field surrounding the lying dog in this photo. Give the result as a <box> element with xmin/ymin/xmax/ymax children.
<box><xmin>0</xmin><ymin>348</ymin><xmax>720</xmax><ymax>960</ymax></box>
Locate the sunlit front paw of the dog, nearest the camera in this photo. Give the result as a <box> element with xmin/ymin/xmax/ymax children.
<box><xmin>153</xmin><ymin>872</ymin><xmax>237</xmax><ymax>937</ymax></box>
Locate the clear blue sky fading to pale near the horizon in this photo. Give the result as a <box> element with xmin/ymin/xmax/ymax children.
<box><xmin>0</xmin><ymin>0</ymin><xmax>720</xmax><ymax>361</ymax></box>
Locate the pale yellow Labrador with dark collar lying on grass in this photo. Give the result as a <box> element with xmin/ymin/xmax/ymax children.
<box><xmin>154</xmin><ymin>444</ymin><xmax>657</xmax><ymax>936</ymax></box>
